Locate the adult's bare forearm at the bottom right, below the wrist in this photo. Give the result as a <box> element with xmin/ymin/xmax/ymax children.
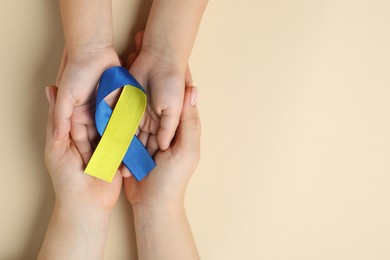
<box><xmin>133</xmin><ymin>204</ymin><xmax>199</xmax><ymax>260</ymax></box>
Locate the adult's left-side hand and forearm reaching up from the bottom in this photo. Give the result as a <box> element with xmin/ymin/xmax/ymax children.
<box><xmin>38</xmin><ymin>86</ymin><xmax>122</xmax><ymax>260</ymax></box>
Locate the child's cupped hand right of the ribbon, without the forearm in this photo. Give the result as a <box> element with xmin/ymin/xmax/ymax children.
<box><xmin>127</xmin><ymin>32</ymin><xmax>192</xmax><ymax>155</ymax></box>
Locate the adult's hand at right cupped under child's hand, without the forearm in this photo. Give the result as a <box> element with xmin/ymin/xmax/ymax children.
<box><xmin>124</xmin><ymin>87</ymin><xmax>201</xmax><ymax>209</ymax></box>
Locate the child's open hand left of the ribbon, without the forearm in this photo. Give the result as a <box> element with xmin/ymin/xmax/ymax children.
<box><xmin>54</xmin><ymin>47</ymin><xmax>120</xmax><ymax>164</ymax></box>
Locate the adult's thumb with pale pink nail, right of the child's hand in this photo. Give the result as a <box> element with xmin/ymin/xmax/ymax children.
<box><xmin>173</xmin><ymin>87</ymin><xmax>201</xmax><ymax>154</ymax></box>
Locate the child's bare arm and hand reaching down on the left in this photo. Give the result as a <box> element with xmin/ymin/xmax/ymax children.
<box><xmin>54</xmin><ymin>0</ymin><xmax>119</xmax><ymax>141</ymax></box>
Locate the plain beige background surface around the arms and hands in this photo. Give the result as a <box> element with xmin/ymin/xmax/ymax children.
<box><xmin>0</xmin><ymin>0</ymin><xmax>390</xmax><ymax>260</ymax></box>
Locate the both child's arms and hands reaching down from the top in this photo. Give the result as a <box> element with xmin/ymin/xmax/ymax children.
<box><xmin>54</xmin><ymin>0</ymin><xmax>207</xmax><ymax>158</ymax></box>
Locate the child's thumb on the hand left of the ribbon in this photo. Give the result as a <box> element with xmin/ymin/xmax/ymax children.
<box><xmin>54</xmin><ymin>88</ymin><xmax>73</xmax><ymax>140</ymax></box>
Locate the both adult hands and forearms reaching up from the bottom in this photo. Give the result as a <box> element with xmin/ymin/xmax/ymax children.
<box><xmin>38</xmin><ymin>84</ymin><xmax>200</xmax><ymax>260</ymax></box>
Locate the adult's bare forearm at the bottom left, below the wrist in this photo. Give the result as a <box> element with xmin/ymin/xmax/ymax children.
<box><xmin>38</xmin><ymin>205</ymin><xmax>109</xmax><ymax>260</ymax></box>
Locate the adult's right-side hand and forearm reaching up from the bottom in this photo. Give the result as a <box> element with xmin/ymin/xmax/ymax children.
<box><xmin>124</xmin><ymin>88</ymin><xmax>201</xmax><ymax>260</ymax></box>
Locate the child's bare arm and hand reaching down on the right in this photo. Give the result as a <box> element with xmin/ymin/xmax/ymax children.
<box><xmin>130</xmin><ymin>0</ymin><xmax>207</xmax><ymax>150</ymax></box>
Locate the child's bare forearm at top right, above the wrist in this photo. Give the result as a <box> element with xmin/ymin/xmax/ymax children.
<box><xmin>142</xmin><ymin>0</ymin><xmax>207</xmax><ymax>69</ymax></box>
